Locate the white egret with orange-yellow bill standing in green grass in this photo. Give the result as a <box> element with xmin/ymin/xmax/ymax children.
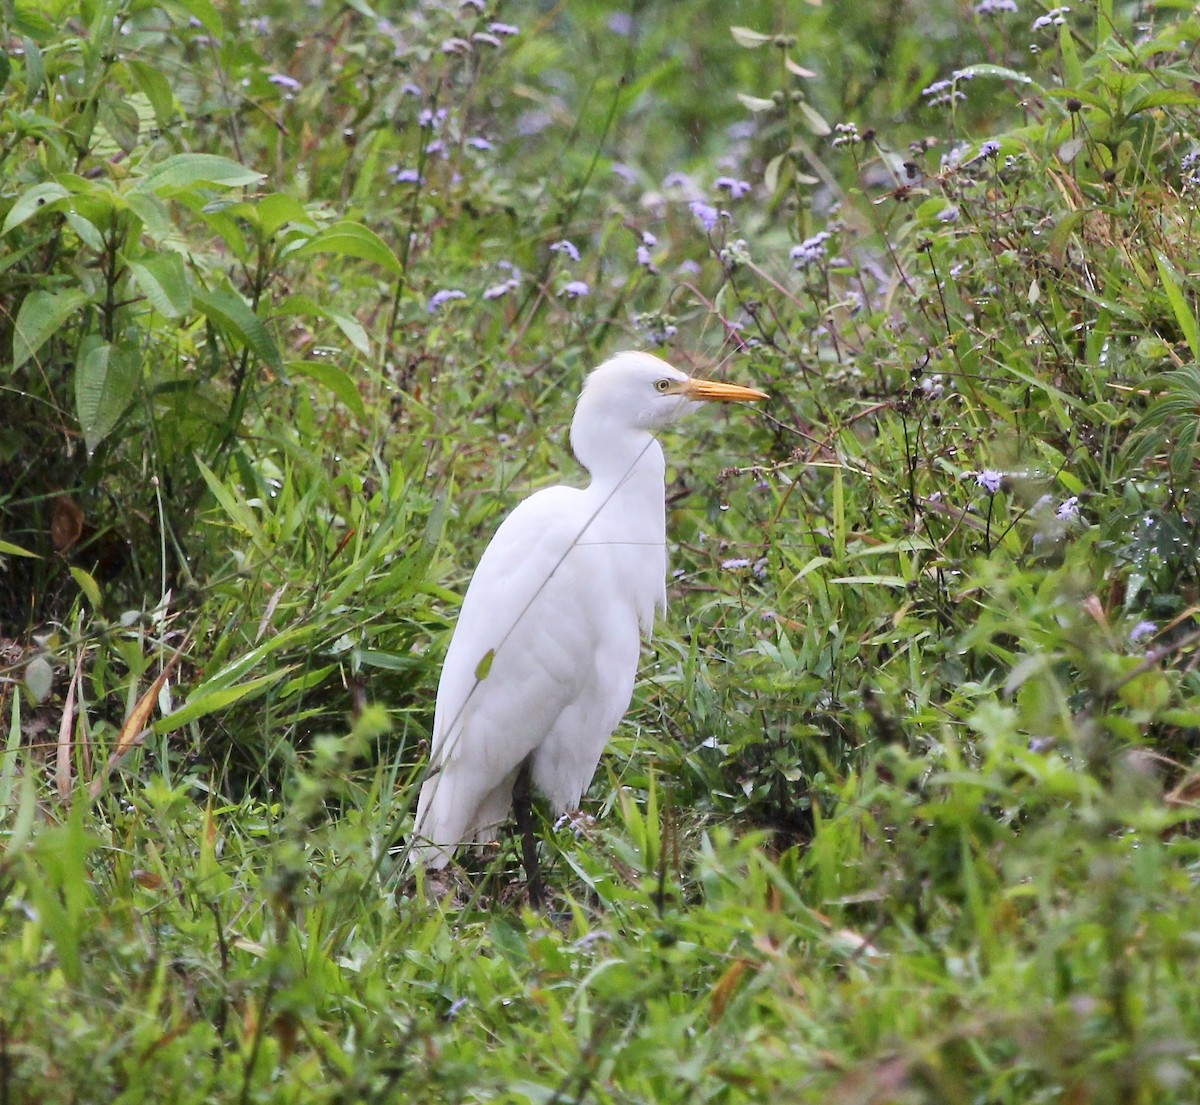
<box><xmin>415</xmin><ymin>353</ymin><xmax>767</xmax><ymax>905</ymax></box>
